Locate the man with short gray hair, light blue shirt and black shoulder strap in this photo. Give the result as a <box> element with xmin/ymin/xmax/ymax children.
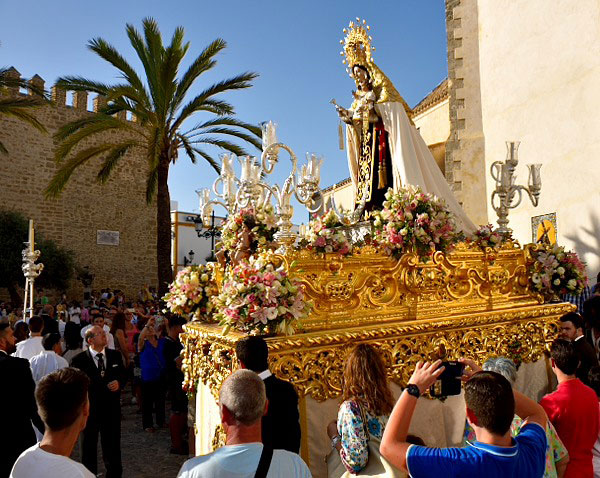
<box><xmin>177</xmin><ymin>370</ymin><xmax>312</xmax><ymax>478</ymax></box>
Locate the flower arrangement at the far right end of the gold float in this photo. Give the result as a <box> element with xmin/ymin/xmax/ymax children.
<box><xmin>529</xmin><ymin>244</ymin><xmax>588</xmax><ymax>297</ymax></box>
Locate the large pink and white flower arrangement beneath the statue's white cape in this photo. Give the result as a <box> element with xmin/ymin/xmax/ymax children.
<box><xmin>371</xmin><ymin>186</ymin><xmax>462</xmax><ymax>259</ymax></box>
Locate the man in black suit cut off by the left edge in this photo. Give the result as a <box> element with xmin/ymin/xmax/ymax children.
<box><xmin>0</xmin><ymin>323</ymin><xmax>44</xmax><ymax>478</ymax></box>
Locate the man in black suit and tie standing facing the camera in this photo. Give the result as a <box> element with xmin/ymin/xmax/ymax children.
<box><xmin>71</xmin><ymin>326</ymin><xmax>126</xmax><ymax>478</ymax></box>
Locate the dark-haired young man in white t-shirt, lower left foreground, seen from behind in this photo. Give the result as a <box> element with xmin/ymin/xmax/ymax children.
<box><xmin>10</xmin><ymin>368</ymin><xmax>94</xmax><ymax>478</ymax></box>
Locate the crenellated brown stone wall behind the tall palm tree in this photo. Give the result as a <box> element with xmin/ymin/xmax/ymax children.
<box><xmin>0</xmin><ymin>70</ymin><xmax>156</xmax><ymax>298</ymax></box>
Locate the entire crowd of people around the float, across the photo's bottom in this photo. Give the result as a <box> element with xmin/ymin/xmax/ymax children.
<box><xmin>0</xmin><ymin>294</ymin><xmax>600</xmax><ymax>478</ymax></box>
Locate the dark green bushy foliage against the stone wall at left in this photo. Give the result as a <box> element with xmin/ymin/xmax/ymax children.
<box><xmin>0</xmin><ymin>210</ymin><xmax>75</xmax><ymax>291</ymax></box>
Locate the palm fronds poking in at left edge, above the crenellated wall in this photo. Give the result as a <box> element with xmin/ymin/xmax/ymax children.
<box><xmin>0</xmin><ymin>68</ymin><xmax>48</xmax><ymax>154</ymax></box>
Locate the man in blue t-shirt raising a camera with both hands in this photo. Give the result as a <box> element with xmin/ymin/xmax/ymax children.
<box><xmin>380</xmin><ymin>359</ymin><xmax>546</xmax><ymax>478</ymax></box>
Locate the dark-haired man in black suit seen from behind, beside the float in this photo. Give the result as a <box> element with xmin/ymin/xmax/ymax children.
<box><xmin>235</xmin><ymin>336</ymin><xmax>300</xmax><ymax>453</ymax></box>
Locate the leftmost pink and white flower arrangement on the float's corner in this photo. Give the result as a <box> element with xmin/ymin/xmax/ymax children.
<box><xmin>163</xmin><ymin>263</ymin><xmax>218</xmax><ymax>322</ymax></box>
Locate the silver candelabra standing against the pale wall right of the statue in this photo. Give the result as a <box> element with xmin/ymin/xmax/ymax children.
<box><xmin>490</xmin><ymin>141</ymin><xmax>542</xmax><ymax>234</ymax></box>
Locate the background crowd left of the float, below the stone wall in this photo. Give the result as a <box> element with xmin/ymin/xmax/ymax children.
<box><xmin>0</xmin><ymin>289</ymin><xmax>189</xmax><ymax>478</ymax></box>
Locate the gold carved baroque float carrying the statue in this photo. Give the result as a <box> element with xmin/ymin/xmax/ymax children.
<box><xmin>183</xmin><ymin>242</ymin><xmax>573</xmax><ymax>401</ymax></box>
